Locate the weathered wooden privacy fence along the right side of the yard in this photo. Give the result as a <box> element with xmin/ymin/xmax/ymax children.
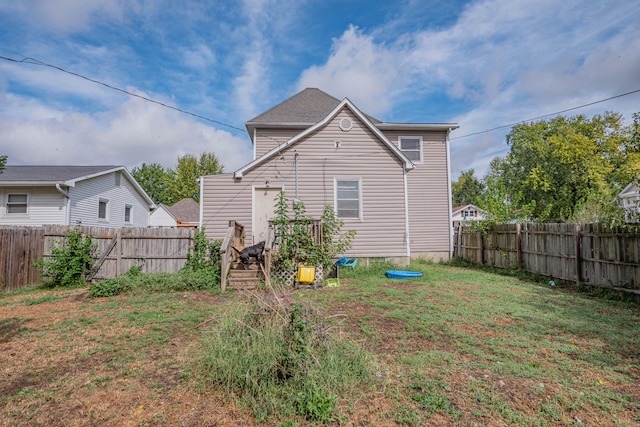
<box><xmin>454</xmin><ymin>224</ymin><xmax>640</xmax><ymax>295</ymax></box>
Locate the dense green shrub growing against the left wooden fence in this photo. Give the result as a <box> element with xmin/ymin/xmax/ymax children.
<box><xmin>35</xmin><ymin>228</ymin><xmax>96</xmax><ymax>287</ymax></box>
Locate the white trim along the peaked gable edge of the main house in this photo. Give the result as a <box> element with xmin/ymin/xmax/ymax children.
<box><xmin>233</xmin><ymin>98</ymin><xmax>415</xmax><ymax>179</ymax></box>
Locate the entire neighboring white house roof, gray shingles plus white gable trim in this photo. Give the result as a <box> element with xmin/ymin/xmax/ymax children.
<box><xmin>0</xmin><ymin>165</ymin><xmax>155</xmax><ymax>207</ymax></box>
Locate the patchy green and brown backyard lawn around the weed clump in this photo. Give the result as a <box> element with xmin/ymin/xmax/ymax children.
<box><xmin>0</xmin><ymin>263</ymin><xmax>640</xmax><ymax>427</ymax></box>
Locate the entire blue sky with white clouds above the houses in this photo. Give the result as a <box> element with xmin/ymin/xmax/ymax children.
<box><xmin>0</xmin><ymin>0</ymin><xmax>640</xmax><ymax>179</ymax></box>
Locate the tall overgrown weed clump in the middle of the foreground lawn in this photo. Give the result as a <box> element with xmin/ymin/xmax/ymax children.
<box><xmin>200</xmin><ymin>293</ymin><xmax>373</xmax><ymax>423</ymax></box>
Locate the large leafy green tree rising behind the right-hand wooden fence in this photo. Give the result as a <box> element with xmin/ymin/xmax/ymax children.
<box><xmin>490</xmin><ymin>112</ymin><xmax>640</xmax><ymax>222</ymax></box>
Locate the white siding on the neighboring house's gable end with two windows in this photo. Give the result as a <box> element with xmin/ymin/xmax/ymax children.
<box><xmin>69</xmin><ymin>173</ymin><xmax>149</xmax><ymax>228</ymax></box>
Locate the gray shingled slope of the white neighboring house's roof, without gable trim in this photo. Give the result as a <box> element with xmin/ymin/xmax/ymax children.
<box><xmin>0</xmin><ymin>166</ymin><xmax>122</xmax><ymax>184</ymax></box>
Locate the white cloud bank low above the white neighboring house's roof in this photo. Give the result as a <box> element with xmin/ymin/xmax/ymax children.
<box><xmin>0</xmin><ymin>93</ymin><xmax>252</xmax><ymax>172</ymax></box>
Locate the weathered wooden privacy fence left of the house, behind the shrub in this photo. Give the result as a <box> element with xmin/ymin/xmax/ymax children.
<box><xmin>0</xmin><ymin>225</ymin><xmax>197</xmax><ymax>292</ymax></box>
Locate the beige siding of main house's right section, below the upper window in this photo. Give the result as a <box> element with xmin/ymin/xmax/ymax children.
<box><xmin>385</xmin><ymin>131</ymin><xmax>451</xmax><ymax>256</ymax></box>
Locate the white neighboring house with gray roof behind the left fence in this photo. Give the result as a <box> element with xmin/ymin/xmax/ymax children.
<box><xmin>0</xmin><ymin>166</ymin><xmax>155</xmax><ymax>228</ymax></box>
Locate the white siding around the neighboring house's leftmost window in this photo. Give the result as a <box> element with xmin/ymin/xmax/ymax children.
<box><xmin>0</xmin><ymin>187</ymin><xmax>67</xmax><ymax>227</ymax></box>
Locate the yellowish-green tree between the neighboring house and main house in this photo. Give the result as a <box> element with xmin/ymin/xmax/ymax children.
<box><xmin>167</xmin><ymin>153</ymin><xmax>223</xmax><ymax>204</ymax></box>
